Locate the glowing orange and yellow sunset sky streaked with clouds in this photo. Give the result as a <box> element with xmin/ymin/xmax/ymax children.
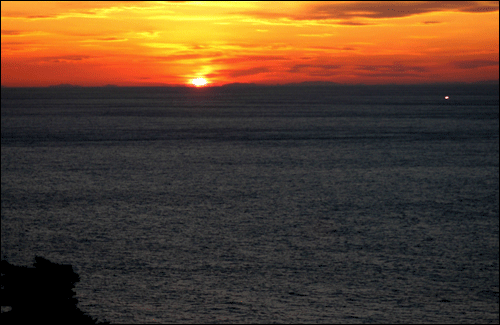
<box><xmin>1</xmin><ymin>1</ymin><xmax>499</xmax><ymax>86</ymax></box>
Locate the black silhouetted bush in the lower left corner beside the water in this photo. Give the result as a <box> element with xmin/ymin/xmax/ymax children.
<box><xmin>0</xmin><ymin>256</ymin><xmax>109</xmax><ymax>325</ymax></box>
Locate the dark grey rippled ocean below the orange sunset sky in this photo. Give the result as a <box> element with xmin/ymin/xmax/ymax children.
<box><xmin>1</xmin><ymin>85</ymin><xmax>499</xmax><ymax>324</ymax></box>
